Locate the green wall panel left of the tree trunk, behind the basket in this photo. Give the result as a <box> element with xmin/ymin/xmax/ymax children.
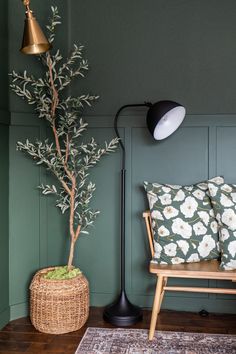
<box><xmin>9</xmin><ymin>126</ymin><xmax>40</xmax><ymax>318</ymax></box>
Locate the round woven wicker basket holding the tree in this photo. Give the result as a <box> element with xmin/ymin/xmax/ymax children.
<box><xmin>30</xmin><ymin>267</ymin><xmax>89</xmax><ymax>334</ymax></box>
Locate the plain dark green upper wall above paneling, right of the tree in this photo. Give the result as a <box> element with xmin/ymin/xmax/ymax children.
<box><xmin>69</xmin><ymin>0</ymin><xmax>236</xmax><ymax>114</ymax></box>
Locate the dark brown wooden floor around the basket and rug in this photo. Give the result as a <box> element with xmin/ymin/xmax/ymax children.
<box><xmin>0</xmin><ymin>308</ymin><xmax>236</xmax><ymax>354</ymax></box>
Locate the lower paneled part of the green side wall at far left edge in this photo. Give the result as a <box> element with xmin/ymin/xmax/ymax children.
<box><xmin>0</xmin><ymin>120</ymin><xmax>9</xmax><ymax>328</ymax></box>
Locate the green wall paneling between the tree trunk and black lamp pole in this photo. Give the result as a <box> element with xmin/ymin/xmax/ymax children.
<box><xmin>71</xmin><ymin>129</ymin><xmax>120</xmax><ymax>299</ymax></box>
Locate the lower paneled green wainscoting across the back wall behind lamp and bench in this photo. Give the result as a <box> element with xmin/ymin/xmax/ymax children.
<box><xmin>10</xmin><ymin>111</ymin><xmax>236</xmax><ymax>318</ymax></box>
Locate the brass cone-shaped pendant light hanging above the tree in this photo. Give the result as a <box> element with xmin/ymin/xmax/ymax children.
<box><xmin>20</xmin><ymin>0</ymin><xmax>51</xmax><ymax>54</ymax></box>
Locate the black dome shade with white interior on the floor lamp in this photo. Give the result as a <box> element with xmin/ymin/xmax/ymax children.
<box><xmin>147</xmin><ymin>101</ymin><xmax>186</xmax><ymax>140</ymax></box>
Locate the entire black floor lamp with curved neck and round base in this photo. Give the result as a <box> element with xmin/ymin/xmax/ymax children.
<box><xmin>103</xmin><ymin>101</ymin><xmax>186</xmax><ymax>326</ymax></box>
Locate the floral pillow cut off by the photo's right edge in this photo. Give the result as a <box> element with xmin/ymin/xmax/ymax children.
<box><xmin>208</xmin><ymin>182</ymin><xmax>236</xmax><ymax>270</ymax></box>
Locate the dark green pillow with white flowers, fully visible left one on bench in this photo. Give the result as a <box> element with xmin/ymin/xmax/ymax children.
<box><xmin>144</xmin><ymin>177</ymin><xmax>224</xmax><ymax>264</ymax></box>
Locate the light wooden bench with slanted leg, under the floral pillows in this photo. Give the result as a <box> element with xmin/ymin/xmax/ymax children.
<box><xmin>143</xmin><ymin>211</ymin><xmax>236</xmax><ymax>340</ymax></box>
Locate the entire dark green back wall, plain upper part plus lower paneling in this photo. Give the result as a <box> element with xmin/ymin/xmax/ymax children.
<box><xmin>10</xmin><ymin>0</ymin><xmax>236</xmax><ymax>318</ymax></box>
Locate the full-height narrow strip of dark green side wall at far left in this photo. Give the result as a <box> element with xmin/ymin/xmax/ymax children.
<box><xmin>0</xmin><ymin>1</ymin><xmax>9</xmax><ymax>328</ymax></box>
